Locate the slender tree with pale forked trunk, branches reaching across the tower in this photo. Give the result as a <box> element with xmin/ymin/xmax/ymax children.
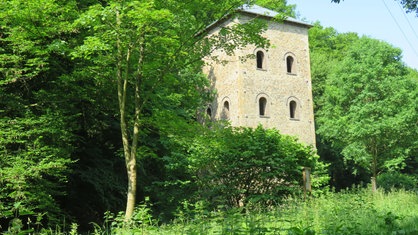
<box><xmin>73</xmin><ymin>0</ymin><xmax>265</xmax><ymax>219</ymax></box>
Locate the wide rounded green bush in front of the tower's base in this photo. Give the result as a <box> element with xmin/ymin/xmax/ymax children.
<box><xmin>189</xmin><ymin>126</ymin><xmax>328</xmax><ymax>207</ymax></box>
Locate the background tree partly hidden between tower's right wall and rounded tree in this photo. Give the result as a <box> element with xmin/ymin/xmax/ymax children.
<box><xmin>309</xmin><ymin>22</ymin><xmax>367</xmax><ymax>190</ymax></box>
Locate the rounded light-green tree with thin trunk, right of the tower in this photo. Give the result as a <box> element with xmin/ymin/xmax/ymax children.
<box><xmin>317</xmin><ymin>37</ymin><xmax>417</xmax><ymax>191</ymax></box>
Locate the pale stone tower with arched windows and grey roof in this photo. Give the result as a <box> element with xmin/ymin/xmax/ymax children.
<box><xmin>204</xmin><ymin>5</ymin><xmax>315</xmax><ymax>146</ymax></box>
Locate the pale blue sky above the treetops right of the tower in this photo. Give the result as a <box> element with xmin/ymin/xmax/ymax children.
<box><xmin>287</xmin><ymin>0</ymin><xmax>418</xmax><ymax>69</ymax></box>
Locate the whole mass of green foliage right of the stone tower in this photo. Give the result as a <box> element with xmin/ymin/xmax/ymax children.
<box><xmin>309</xmin><ymin>23</ymin><xmax>417</xmax><ymax>189</ymax></box>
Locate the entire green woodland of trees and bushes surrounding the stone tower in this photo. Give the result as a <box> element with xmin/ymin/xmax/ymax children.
<box><xmin>0</xmin><ymin>0</ymin><xmax>418</xmax><ymax>231</ymax></box>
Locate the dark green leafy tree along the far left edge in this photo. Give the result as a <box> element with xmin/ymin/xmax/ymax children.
<box><xmin>0</xmin><ymin>0</ymin><xmax>77</xmax><ymax>225</ymax></box>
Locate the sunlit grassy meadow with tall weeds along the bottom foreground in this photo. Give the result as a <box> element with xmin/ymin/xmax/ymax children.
<box><xmin>88</xmin><ymin>189</ymin><xmax>418</xmax><ymax>235</ymax></box>
